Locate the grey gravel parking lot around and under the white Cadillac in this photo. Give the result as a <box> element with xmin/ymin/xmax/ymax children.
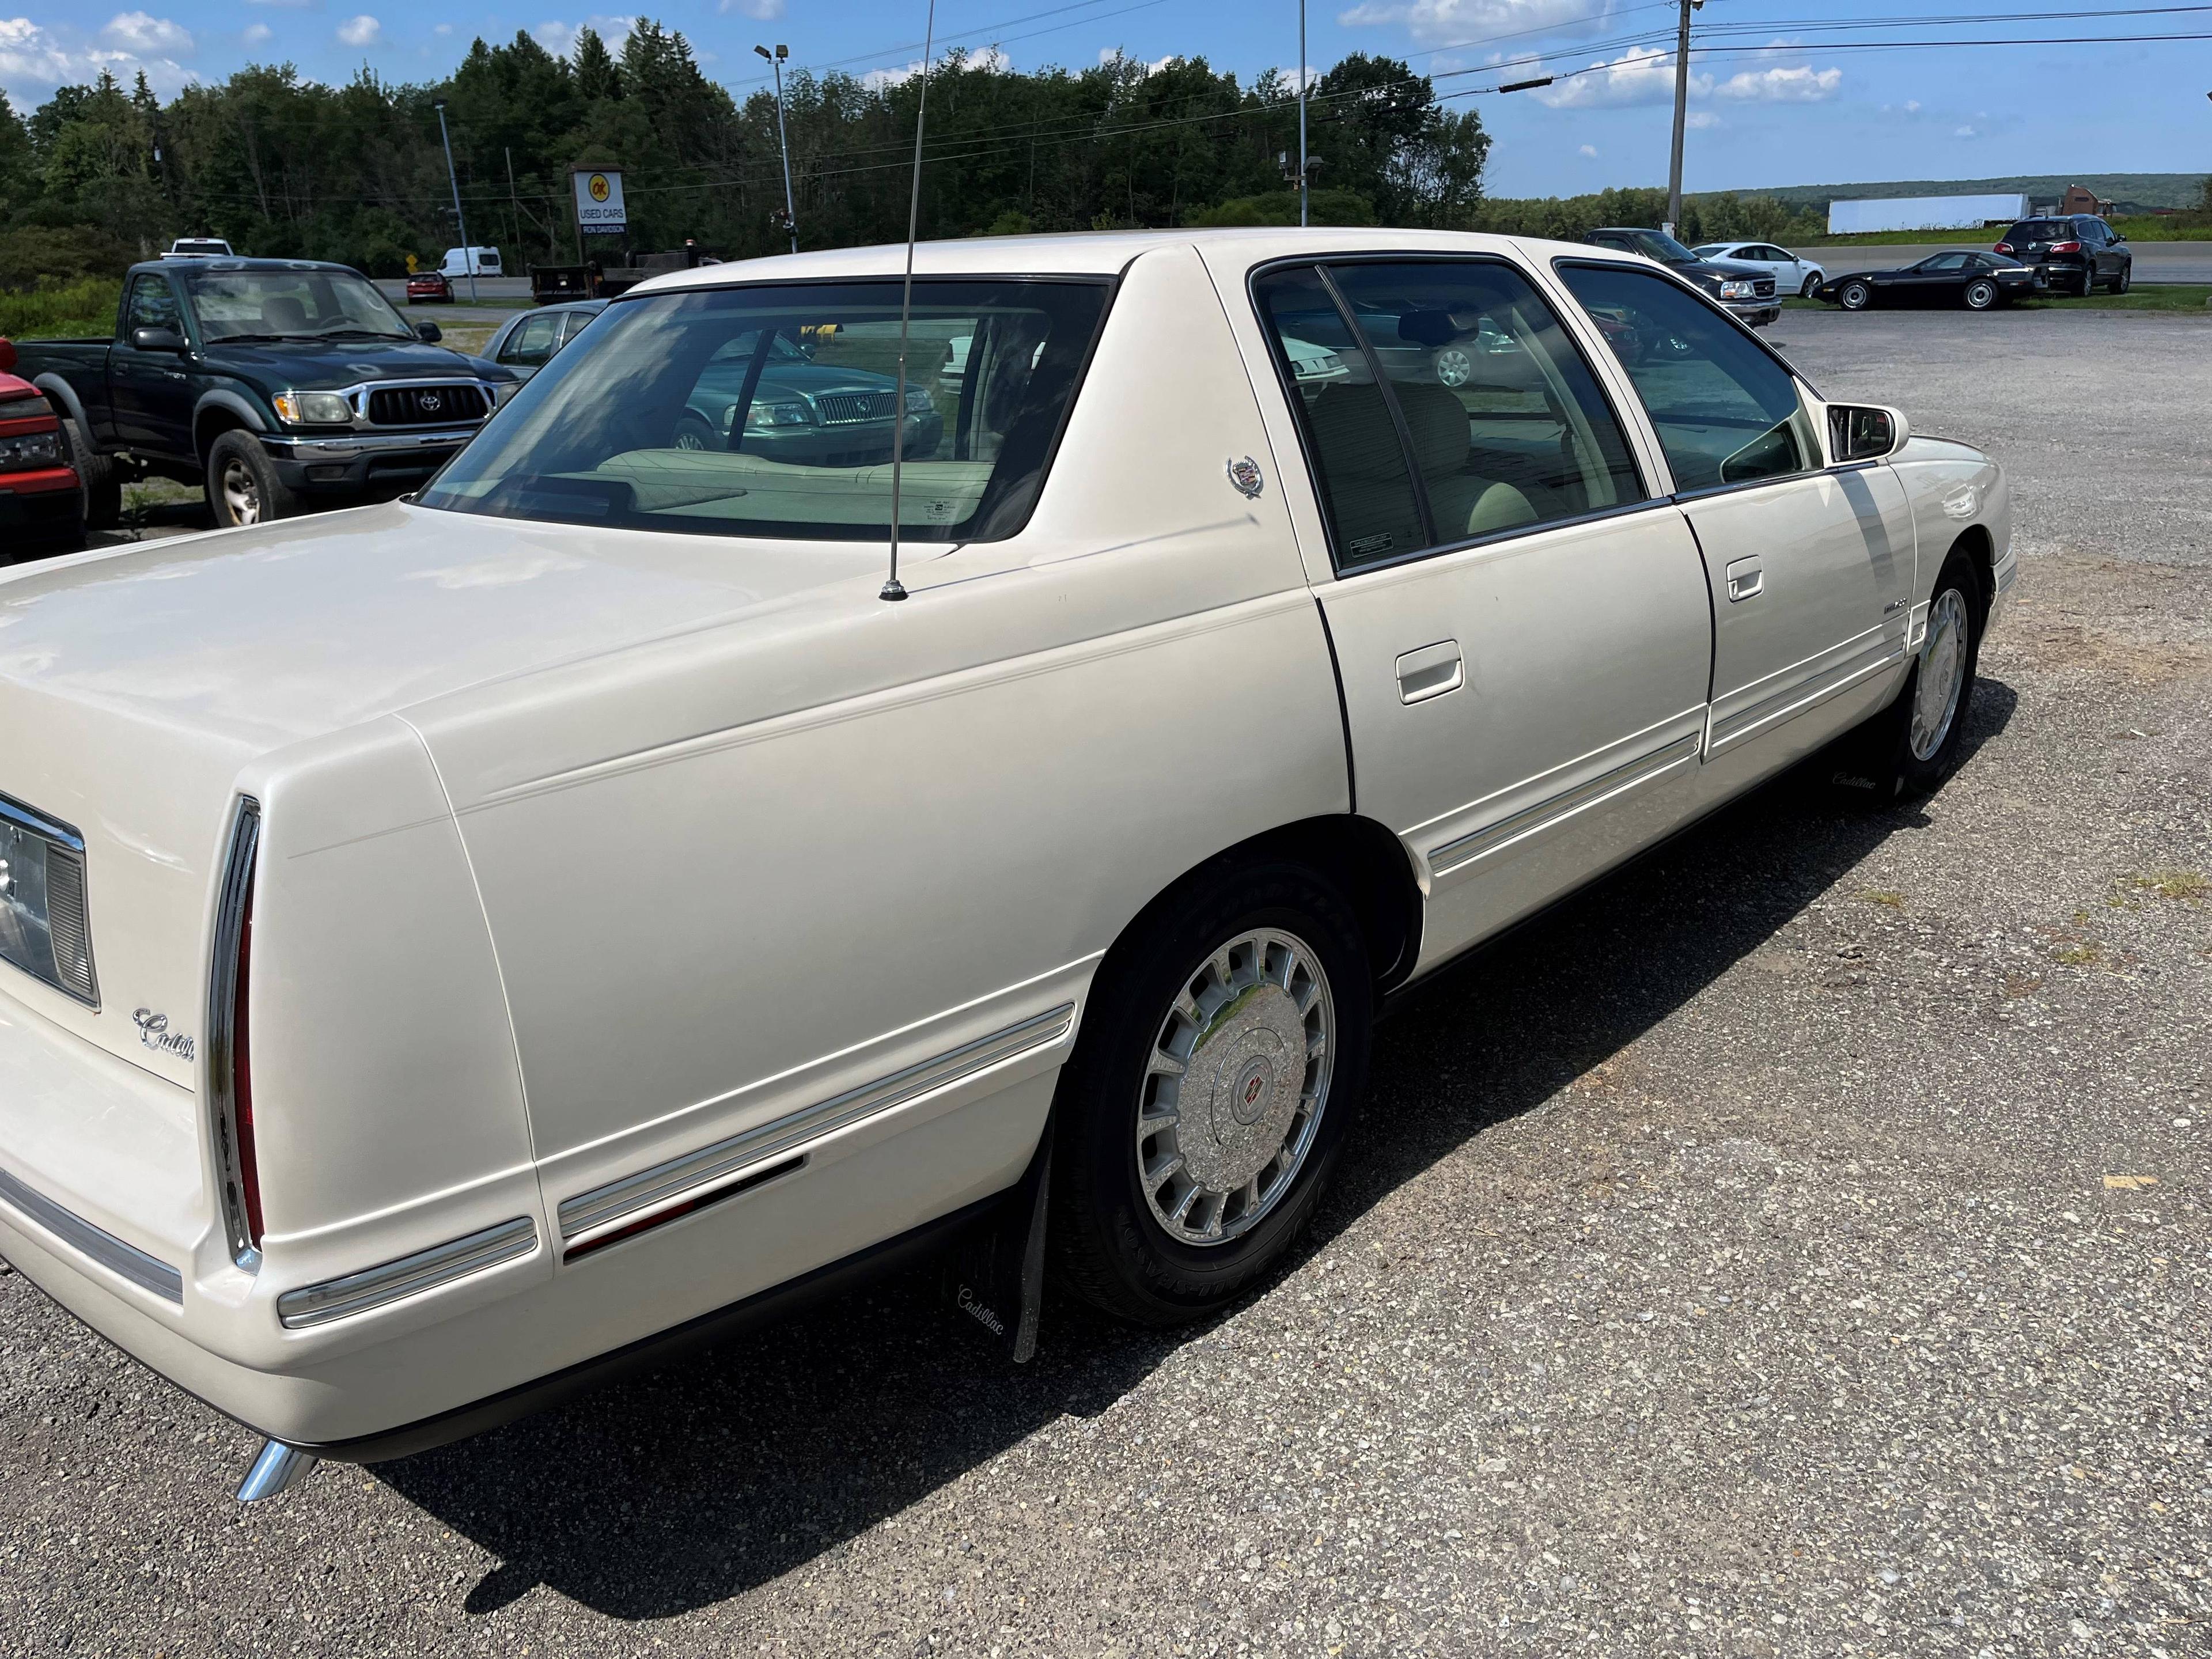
<box><xmin>0</xmin><ymin>312</ymin><xmax>2212</xmax><ymax>1659</ymax></box>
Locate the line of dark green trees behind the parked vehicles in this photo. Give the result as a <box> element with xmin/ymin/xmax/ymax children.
<box><xmin>0</xmin><ymin>22</ymin><xmax>1818</xmax><ymax>292</ymax></box>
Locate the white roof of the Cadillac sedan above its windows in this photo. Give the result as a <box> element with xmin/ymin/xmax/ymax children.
<box><xmin>617</xmin><ymin>226</ymin><xmax>1628</xmax><ymax>303</ymax></box>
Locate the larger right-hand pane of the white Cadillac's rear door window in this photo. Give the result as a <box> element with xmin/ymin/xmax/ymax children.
<box><xmin>1314</xmin><ymin>261</ymin><xmax>1643</xmax><ymax>546</ymax></box>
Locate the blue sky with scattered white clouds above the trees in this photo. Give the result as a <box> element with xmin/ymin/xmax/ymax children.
<box><xmin>0</xmin><ymin>0</ymin><xmax>2212</xmax><ymax>195</ymax></box>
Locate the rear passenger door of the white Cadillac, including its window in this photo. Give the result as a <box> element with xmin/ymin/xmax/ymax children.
<box><xmin>1254</xmin><ymin>256</ymin><xmax>1710</xmax><ymax>967</ymax></box>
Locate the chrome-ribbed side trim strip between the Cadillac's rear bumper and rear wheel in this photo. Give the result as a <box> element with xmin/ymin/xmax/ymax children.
<box><xmin>560</xmin><ymin>1002</ymin><xmax>1075</xmax><ymax>1238</ymax></box>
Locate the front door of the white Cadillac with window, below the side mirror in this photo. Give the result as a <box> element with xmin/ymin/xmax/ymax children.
<box><xmin>1559</xmin><ymin>261</ymin><xmax>1914</xmax><ymax>766</ymax></box>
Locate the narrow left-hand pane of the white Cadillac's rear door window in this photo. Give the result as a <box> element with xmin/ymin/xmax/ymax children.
<box><xmin>1254</xmin><ymin>270</ymin><xmax>1427</xmax><ymax>569</ymax></box>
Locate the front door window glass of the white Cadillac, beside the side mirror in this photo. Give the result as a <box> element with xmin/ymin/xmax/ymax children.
<box><xmin>1559</xmin><ymin>266</ymin><xmax>1820</xmax><ymax>489</ymax></box>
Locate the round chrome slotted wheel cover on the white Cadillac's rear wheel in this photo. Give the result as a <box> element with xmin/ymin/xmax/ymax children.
<box><xmin>1132</xmin><ymin>927</ymin><xmax>1336</xmax><ymax>1245</ymax></box>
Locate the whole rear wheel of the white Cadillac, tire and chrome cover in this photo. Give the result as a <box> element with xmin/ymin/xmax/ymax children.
<box><xmin>1048</xmin><ymin>865</ymin><xmax>1374</xmax><ymax>1325</ymax></box>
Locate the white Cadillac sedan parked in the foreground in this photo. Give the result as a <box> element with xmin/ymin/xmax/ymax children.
<box><xmin>0</xmin><ymin>230</ymin><xmax>2015</xmax><ymax>1495</ymax></box>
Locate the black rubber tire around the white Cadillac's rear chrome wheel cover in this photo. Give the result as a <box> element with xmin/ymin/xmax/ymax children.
<box><xmin>1048</xmin><ymin>863</ymin><xmax>1374</xmax><ymax>1325</ymax></box>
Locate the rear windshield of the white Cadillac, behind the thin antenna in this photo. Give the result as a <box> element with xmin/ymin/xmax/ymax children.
<box><xmin>418</xmin><ymin>279</ymin><xmax>1106</xmax><ymax>542</ymax></box>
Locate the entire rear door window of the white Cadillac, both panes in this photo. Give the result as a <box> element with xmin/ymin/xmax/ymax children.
<box><xmin>1256</xmin><ymin>261</ymin><xmax>1643</xmax><ymax>569</ymax></box>
